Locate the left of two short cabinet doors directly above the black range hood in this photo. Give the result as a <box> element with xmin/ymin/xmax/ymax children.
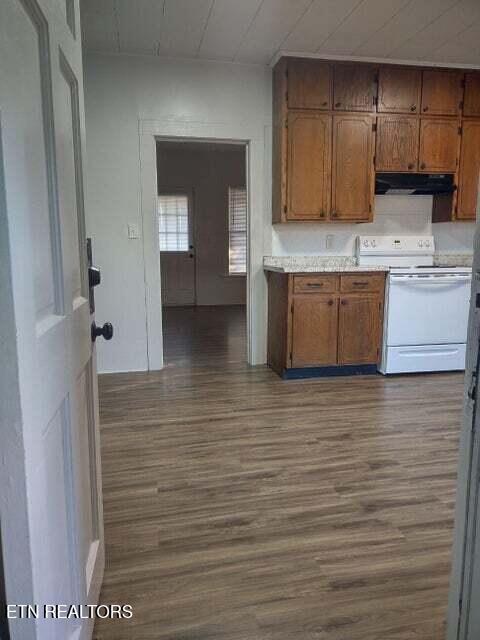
<box><xmin>375</xmin><ymin>116</ymin><xmax>420</xmax><ymax>171</ymax></box>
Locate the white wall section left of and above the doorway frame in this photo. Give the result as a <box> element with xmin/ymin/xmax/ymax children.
<box><xmin>85</xmin><ymin>55</ymin><xmax>271</xmax><ymax>372</ymax></box>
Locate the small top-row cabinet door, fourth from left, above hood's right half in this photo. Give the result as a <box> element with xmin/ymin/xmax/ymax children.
<box><xmin>422</xmin><ymin>69</ymin><xmax>463</xmax><ymax>116</ymax></box>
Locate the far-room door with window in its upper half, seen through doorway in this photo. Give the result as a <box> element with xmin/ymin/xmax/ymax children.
<box><xmin>158</xmin><ymin>190</ymin><xmax>196</xmax><ymax>306</ymax></box>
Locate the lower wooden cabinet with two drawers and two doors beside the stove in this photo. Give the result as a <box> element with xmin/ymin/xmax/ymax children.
<box><xmin>268</xmin><ymin>273</ymin><xmax>385</xmax><ymax>375</ymax></box>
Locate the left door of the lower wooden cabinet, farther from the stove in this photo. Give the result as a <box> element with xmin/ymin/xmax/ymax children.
<box><xmin>292</xmin><ymin>295</ymin><xmax>338</xmax><ymax>367</ymax></box>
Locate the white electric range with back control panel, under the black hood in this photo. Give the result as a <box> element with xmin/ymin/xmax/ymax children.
<box><xmin>357</xmin><ymin>236</ymin><xmax>472</xmax><ymax>374</ymax></box>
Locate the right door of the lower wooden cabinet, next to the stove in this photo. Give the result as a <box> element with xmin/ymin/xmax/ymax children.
<box><xmin>338</xmin><ymin>295</ymin><xmax>382</xmax><ymax>364</ymax></box>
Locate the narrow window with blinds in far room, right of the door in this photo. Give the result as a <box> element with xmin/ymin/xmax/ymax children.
<box><xmin>228</xmin><ymin>187</ymin><xmax>247</xmax><ymax>274</ymax></box>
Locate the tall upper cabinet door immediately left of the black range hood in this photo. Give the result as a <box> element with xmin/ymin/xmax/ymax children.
<box><xmin>331</xmin><ymin>115</ymin><xmax>374</xmax><ymax>221</ymax></box>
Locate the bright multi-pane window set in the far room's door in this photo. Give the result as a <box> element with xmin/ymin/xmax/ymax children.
<box><xmin>158</xmin><ymin>193</ymin><xmax>190</xmax><ymax>251</ymax></box>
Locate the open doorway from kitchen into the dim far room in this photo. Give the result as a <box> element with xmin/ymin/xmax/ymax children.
<box><xmin>156</xmin><ymin>140</ymin><xmax>248</xmax><ymax>366</ymax></box>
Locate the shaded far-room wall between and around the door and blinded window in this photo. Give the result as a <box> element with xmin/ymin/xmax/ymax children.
<box><xmin>157</xmin><ymin>142</ymin><xmax>247</xmax><ymax>305</ymax></box>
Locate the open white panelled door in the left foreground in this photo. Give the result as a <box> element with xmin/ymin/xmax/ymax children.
<box><xmin>0</xmin><ymin>0</ymin><xmax>104</xmax><ymax>640</ymax></box>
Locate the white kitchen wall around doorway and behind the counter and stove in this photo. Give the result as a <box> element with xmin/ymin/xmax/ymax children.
<box><xmin>85</xmin><ymin>54</ymin><xmax>474</xmax><ymax>372</ymax></box>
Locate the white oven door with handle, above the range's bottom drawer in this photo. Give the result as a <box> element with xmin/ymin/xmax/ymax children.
<box><xmin>386</xmin><ymin>274</ymin><xmax>471</xmax><ymax>346</ymax></box>
